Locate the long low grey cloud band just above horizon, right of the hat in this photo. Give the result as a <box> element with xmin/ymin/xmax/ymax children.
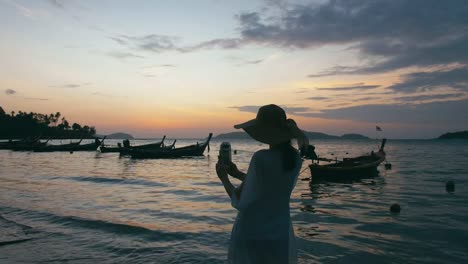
<box><xmin>308</xmin><ymin>100</ymin><xmax>468</xmax><ymax>125</ymax></box>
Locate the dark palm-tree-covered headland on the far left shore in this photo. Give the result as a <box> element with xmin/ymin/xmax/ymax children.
<box><xmin>0</xmin><ymin>106</ymin><xmax>96</xmax><ymax>139</ymax></box>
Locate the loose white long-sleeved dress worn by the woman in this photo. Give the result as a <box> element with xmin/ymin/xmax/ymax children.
<box><xmin>228</xmin><ymin>150</ymin><xmax>302</xmax><ymax>264</ymax></box>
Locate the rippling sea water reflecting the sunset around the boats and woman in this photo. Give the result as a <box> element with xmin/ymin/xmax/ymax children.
<box><xmin>0</xmin><ymin>140</ymin><xmax>468</xmax><ymax>263</ymax></box>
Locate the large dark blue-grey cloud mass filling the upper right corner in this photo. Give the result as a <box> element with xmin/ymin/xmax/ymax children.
<box><xmin>238</xmin><ymin>0</ymin><xmax>468</xmax><ymax>69</ymax></box>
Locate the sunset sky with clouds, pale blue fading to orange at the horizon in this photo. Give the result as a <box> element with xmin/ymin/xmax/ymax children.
<box><xmin>0</xmin><ymin>0</ymin><xmax>468</xmax><ymax>139</ymax></box>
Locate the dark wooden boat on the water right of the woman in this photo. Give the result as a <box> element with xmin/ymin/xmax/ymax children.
<box><xmin>309</xmin><ymin>139</ymin><xmax>386</xmax><ymax>182</ymax></box>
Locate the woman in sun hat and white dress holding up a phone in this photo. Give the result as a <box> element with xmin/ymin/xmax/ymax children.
<box><xmin>216</xmin><ymin>105</ymin><xmax>308</xmax><ymax>264</ymax></box>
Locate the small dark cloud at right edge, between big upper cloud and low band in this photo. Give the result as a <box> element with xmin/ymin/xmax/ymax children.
<box><xmin>388</xmin><ymin>67</ymin><xmax>468</xmax><ymax>93</ymax></box>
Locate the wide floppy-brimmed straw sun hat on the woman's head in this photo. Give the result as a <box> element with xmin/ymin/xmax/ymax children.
<box><xmin>234</xmin><ymin>104</ymin><xmax>303</xmax><ymax>145</ymax></box>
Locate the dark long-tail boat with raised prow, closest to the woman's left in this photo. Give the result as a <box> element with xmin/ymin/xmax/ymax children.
<box><xmin>129</xmin><ymin>133</ymin><xmax>213</xmax><ymax>159</ymax></box>
